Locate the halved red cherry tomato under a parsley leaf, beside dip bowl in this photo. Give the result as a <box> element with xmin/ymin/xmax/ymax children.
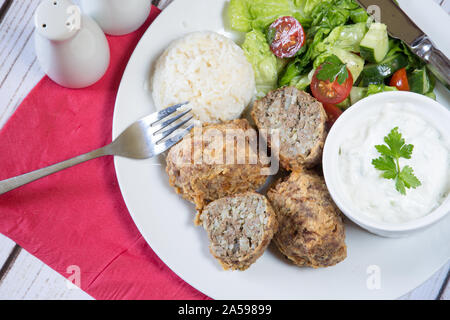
<box><xmin>311</xmin><ymin>66</ymin><xmax>353</xmax><ymax>104</ymax></box>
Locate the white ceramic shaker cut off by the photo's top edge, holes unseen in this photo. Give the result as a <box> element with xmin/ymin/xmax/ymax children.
<box><xmin>81</xmin><ymin>0</ymin><xmax>151</xmax><ymax>36</ymax></box>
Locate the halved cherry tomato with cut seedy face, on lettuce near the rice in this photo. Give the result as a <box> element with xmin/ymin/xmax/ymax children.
<box><xmin>269</xmin><ymin>17</ymin><xmax>306</xmax><ymax>58</ymax></box>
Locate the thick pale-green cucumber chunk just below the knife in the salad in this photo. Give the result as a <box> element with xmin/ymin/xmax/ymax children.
<box><xmin>360</xmin><ymin>22</ymin><xmax>389</xmax><ymax>63</ymax></box>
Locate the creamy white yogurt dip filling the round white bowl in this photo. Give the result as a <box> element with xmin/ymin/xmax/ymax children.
<box><xmin>338</xmin><ymin>102</ymin><xmax>450</xmax><ymax>224</ymax></box>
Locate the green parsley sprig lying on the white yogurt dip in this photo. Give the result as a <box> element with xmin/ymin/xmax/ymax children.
<box><xmin>372</xmin><ymin>127</ymin><xmax>422</xmax><ymax>195</ymax></box>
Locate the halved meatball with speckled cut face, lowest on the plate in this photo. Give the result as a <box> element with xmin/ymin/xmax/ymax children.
<box><xmin>197</xmin><ymin>192</ymin><xmax>278</xmax><ymax>270</ymax></box>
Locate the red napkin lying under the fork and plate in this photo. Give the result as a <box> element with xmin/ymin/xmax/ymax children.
<box><xmin>0</xmin><ymin>7</ymin><xmax>208</xmax><ymax>299</ymax></box>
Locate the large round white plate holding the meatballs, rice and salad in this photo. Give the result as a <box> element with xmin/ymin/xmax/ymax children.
<box><xmin>113</xmin><ymin>0</ymin><xmax>450</xmax><ymax>299</ymax></box>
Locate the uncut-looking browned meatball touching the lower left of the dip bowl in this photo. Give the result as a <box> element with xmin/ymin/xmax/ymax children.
<box><xmin>267</xmin><ymin>171</ymin><xmax>347</xmax><ymax>268</ymax></box>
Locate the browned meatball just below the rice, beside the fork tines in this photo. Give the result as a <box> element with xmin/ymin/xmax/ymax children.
<box><xmin>166</xmin><ymin>120</ymin><xmax>267</xmax><ymax>210</ymax></box>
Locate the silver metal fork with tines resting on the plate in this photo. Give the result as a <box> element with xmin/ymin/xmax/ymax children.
<box><xmin>0</xmin><ymin>102</ymin><xmax>194</xmax><ymax>195</ymax></box>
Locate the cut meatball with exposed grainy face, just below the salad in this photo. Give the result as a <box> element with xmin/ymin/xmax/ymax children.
<box><xmin>252</xmin><ymin>87</ymin><xmax>327</xmax><ymax>170</ymax></box>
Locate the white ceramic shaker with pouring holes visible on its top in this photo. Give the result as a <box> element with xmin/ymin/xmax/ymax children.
<box><xmin>34</xmin><ymin>0</ymin><xmax>110</xmax><ymax>88</ymax></box>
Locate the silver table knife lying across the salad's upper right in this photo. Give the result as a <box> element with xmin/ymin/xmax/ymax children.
<box><xmin>356</xmin><ymin>0</ymin><xmax>450</xmax><ymax>90</ymax></box>
